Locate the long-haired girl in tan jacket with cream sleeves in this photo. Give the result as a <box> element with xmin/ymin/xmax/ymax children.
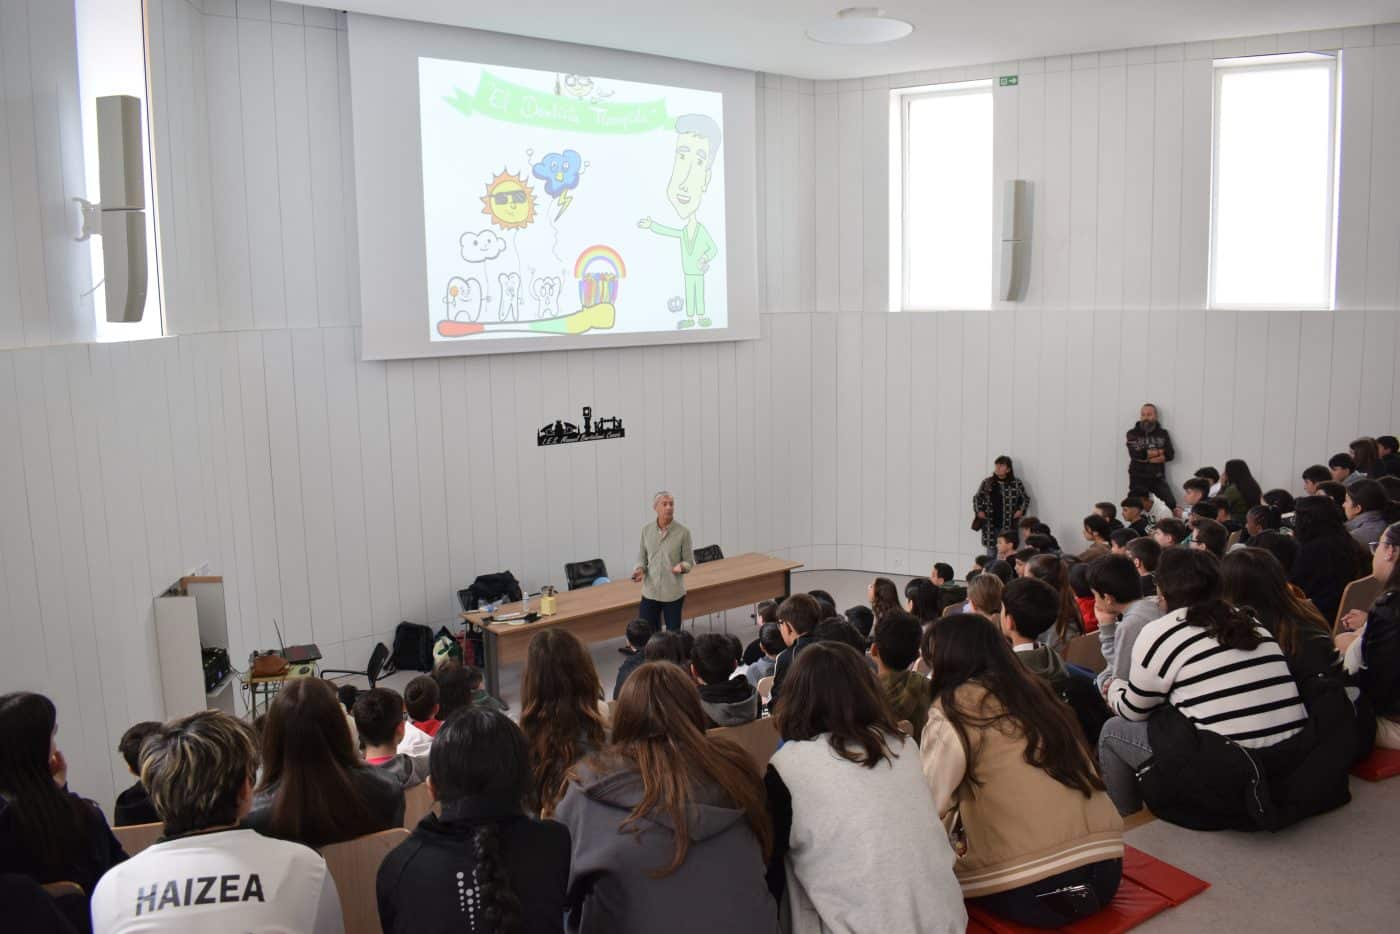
<box><xmin>920</xmin><ymin>616</ymin><xmax>1123</xmax><ymax>927</ymax></box>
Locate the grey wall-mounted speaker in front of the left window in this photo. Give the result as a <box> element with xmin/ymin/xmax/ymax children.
<box><xmin>73</xmin><ymin>94</ymin><xmax>147</xmax><ymax>323</ymax></box>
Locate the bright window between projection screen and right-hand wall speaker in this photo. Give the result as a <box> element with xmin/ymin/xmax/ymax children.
<box><xmin>890</xmin><ymin>81</ymin><xmax>994</xmax><ymax>311</ymax></box>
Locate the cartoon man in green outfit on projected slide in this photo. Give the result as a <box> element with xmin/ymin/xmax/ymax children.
<box><xmin>637</xmin><ymin>113</ymin><xmax>720</xmax><ymax>328</ymax></box>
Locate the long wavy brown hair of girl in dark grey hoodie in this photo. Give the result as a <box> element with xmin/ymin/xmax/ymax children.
<box><xmin>588</xmin><ymin>663</ymin><xmax>772</xmax><ymax>878</ymax></box>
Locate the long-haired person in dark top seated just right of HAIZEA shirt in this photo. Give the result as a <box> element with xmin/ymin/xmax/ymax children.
<box><xmin>242</xmin><ymin>678</ymin><xmax>403</xmax><ymax>850</ymax></box>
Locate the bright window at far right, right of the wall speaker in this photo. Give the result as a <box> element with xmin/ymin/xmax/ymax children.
<box><xmin>1210</xmin><ymin>53</ymin><xmax>1337</xmax><ymax>308</ymax></box>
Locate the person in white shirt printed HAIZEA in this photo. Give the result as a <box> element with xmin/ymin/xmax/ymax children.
<box><xmin>92</xmin><ymin>711</ymin><xmax>344</xmax><ymax>934</ymax></box>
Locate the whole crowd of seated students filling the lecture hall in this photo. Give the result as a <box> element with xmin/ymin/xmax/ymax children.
<box><xmin>8</xmin><ymin>438</ymin><xmax>1400</xmax><ymax>934</ymax></box>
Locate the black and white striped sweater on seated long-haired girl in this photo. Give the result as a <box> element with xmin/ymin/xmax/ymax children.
<box><xmin>1107</xmin><ymin>608</ymin><xmax>1308</xmax><ymax>748</ymax></box>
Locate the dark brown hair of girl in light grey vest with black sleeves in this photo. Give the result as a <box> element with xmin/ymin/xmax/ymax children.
<box><xmin>774</xmin><ymin>646</ymin><xmax>917</xmax><ymax>769</ymax></box>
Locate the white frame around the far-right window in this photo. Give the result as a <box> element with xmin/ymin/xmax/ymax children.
<box><xmin>1205</xmin><ymin>52</ymin><xmax>1341</xmax><ymax>311</ymax></box>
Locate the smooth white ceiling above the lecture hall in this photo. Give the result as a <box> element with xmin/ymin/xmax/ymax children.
<box><xmin>312</xmin><ymin>0</ymin><xmax>1400</xmax><ymax>78</ymax></box>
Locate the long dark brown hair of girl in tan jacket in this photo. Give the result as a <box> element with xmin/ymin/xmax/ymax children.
<box><xmin>918</xmin><ymin>613</ymin><xmax>1103</xmax><ymax>798</ymax></box>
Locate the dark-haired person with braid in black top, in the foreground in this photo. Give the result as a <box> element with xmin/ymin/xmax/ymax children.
<box><xmin>375</xmin><ymin>707</ymin><xmax>571</xmax><ymax>934</ymax></box>
